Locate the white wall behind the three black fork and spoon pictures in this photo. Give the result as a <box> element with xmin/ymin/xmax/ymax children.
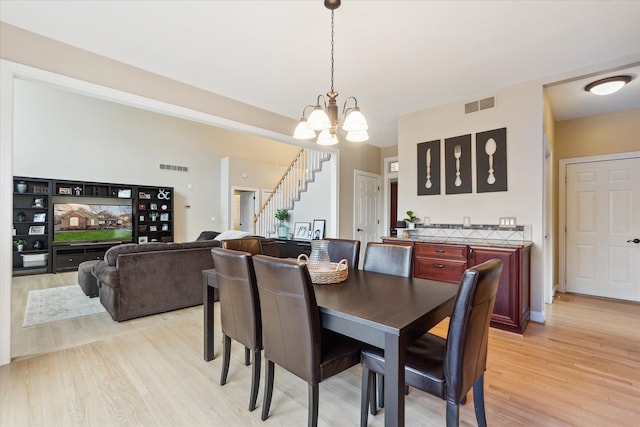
<box><xmin>398</xmin><ymin>82</ymin><xmax>544</xmax><ymax>321</ymax></box>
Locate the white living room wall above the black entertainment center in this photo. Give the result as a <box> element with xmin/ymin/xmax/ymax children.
<box><xmin>13</xmin><ymin>80</ymin><xmax>295</xmax><ymax>241</ymax></box>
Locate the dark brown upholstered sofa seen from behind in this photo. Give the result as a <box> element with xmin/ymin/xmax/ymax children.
<box><xmin>93</xmin><ymin>240</ymin><xmax>220</xmax><ymax>322</ymax></box>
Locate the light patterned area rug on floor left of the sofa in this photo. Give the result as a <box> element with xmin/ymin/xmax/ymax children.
<box><xmin>22</xmin><ymin>285</ymin><xmax>105</xmax><ymax>328</ymax></box>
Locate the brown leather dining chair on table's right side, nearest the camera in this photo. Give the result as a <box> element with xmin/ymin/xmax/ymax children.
<box><xmin>360</xmin><ymin>259</ymin><xmax>502</xmax><ymax>427</ymax></box>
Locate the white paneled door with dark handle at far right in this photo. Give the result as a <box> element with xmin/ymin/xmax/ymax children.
<box><xmin>566</xmin><ymin>158</ymin><xmax>640</xmax><ymax>301</ymax></box>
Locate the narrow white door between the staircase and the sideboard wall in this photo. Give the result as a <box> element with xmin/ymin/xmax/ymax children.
<box><xmin>353</xmin><ymin>171</ymin><xmax>380</xmax><ymax>264</ymax></box>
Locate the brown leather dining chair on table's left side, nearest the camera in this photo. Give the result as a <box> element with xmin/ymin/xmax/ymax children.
<box><xmin>253</xmin><ymin>255</ymin><xmax>362</xmax><ymax>426</ymax></box>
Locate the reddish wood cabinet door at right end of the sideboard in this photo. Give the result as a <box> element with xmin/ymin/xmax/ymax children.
<box><xmin>469</xmin><ymin>246</ymin><xmax>528</xmax><ymax>332</ymax></box>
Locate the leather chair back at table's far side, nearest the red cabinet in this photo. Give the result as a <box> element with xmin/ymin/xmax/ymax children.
<box><xmin>362</xmin><ymin>242</ymin><xmax>413</xmax><ymax>277</ymax></box>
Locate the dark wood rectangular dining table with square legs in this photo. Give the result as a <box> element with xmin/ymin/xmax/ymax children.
<box><xmin>203</xmin><ymin>269</ymin><xmax>458</xmax><ymax>426</ymax></box>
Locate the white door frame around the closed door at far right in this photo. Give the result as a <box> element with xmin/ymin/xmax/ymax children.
<box><xmin>558</xmin><ymin>151</ymin><xmax>640</xmax><ymax>293</ymax></box>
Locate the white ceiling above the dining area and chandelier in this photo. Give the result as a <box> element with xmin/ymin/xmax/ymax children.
<box><xmin>0</xmin><ymin>0</ymin><xmax>640</xmax><ymax>146</ymax></box>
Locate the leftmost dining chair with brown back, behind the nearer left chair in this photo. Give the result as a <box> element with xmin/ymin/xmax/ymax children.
<box><xmin>211</xmin><ymin>248</ymin><xmax>262</xmax><ymax>411</ymax></box>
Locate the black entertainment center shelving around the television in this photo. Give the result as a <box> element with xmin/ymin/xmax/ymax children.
<box><xmin>13</xmin><ymin>176</ymin><xmax>174</xmax><ymax>276</ymax></box>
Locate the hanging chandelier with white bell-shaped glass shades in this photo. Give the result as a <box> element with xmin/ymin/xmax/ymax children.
<box><xmin>293</xmin><ymin>0</ymin><xmax>369</xmax><ymax>145</ymax></box>
